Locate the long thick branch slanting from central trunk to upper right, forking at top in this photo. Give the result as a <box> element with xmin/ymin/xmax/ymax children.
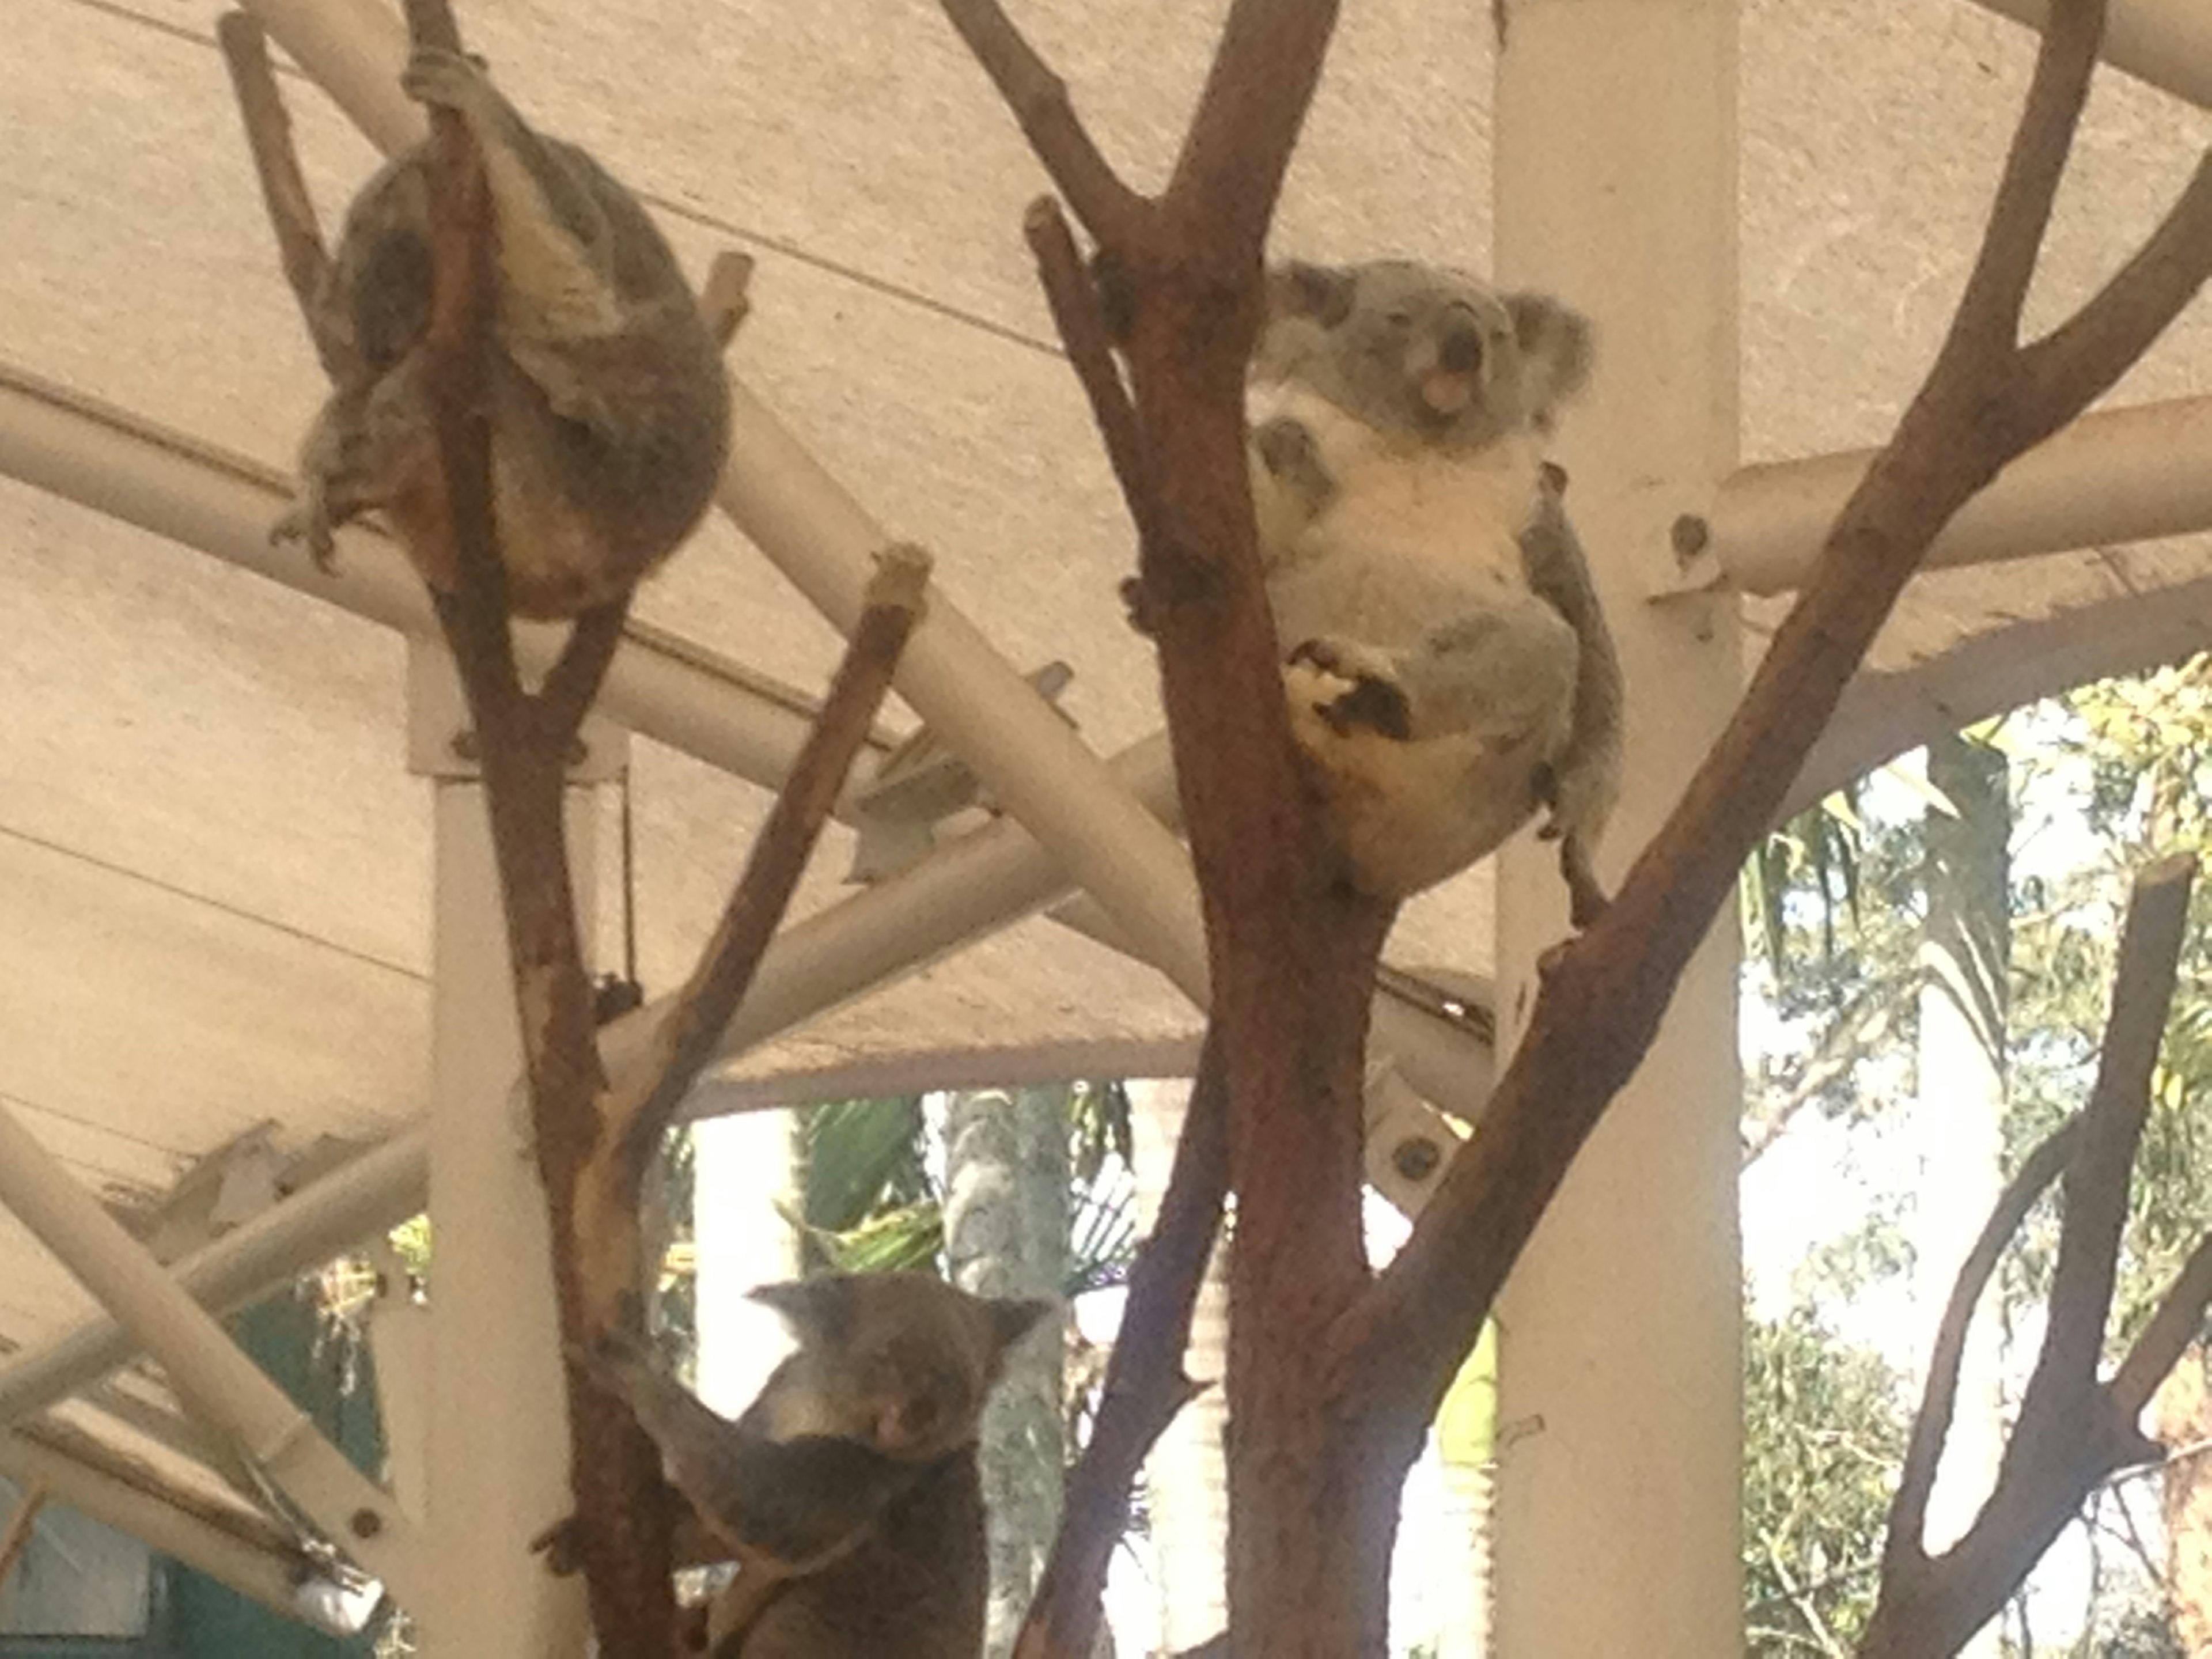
<box><xmin>1336</xmin><ymin>0</ymin><xmax>2212</xmax><ymax>1420</ymax></box>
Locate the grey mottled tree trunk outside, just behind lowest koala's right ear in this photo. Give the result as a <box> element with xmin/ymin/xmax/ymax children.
<box><xmin>945</xmin><ymin>1084</ymin><xmax>1071</xmax><ymax>1659</ymax></box>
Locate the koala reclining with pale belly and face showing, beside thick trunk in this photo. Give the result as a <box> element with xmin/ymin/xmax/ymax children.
<box><xmin>1248</xmin><ymin>261</ymin><xmax>1624</xmax><ymax>925</ymax></box>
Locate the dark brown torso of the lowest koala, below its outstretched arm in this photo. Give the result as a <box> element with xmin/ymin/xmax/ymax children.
<box><xmin>714</xmin><ymin>1446</ymin><xmax>988</xmax><ymax>1659</ymax></box>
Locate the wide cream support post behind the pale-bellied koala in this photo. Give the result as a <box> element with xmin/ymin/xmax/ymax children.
<box><xmin>1475</xmin><ymin>0</ymin><xmax>1743</xmax><ymax>1659</ymax></box>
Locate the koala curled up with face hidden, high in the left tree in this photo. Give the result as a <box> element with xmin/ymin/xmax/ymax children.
<box><xmin>272</xmin><ymin>51</ymin><xmax>730</xmax><ymax>617</ymax></box>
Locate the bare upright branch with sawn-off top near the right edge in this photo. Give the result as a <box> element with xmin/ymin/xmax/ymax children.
<box><xmin>2020</xmin><ymin>856</ymin><xmax>2196</xmax><ymax>1433</ymax></box>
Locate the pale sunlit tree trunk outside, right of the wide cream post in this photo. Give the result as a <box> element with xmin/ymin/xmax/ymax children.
<box><xmin>1914</xmin><ymin>734</ymin><xmax>2013</xmax><ymax>1659</ymax></box>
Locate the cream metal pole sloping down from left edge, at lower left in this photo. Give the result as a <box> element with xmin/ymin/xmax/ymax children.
<box><xmin>0</xmin><ymin>1108</ymin><xmax>427</xmax><ymax>1599</ymax></box>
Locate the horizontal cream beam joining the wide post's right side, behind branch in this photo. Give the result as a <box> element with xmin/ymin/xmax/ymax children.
<box><xmin>1692</xmin><ymin>396</ymin><xmax>2212</xmax><ymax>593</ymax></box>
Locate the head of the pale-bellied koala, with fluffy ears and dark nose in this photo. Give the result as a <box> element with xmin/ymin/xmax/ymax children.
<box><xmin>1252</xmin><ymin>259</ymin><xmax>1590</xmax><ymax>449</ymax></box>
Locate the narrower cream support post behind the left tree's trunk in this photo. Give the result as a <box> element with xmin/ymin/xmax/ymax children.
<box><xmin>407</xmin><ymin>639</ymin><xmax>604</xmax><ymax>1659</ymax></box>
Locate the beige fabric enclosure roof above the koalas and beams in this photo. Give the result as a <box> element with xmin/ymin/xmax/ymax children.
<box><xmin>0</xmin><ymin>0</ymin><xmax>2212</xmax><ymax>1380</ymax></box>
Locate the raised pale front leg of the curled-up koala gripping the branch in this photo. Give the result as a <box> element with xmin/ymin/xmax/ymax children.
<box><xmin>400</xmin><ymin>48</ymin><xmax>630</xmax><ymax>422</ymax></box>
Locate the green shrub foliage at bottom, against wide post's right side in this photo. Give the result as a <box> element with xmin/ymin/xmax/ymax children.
<box><xmin>1743</xmin><ymin>1307</ymin><xmax>1907</xmax><ymax>1659</ymax></box>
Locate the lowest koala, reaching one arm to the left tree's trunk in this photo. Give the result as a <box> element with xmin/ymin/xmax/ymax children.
<box><xmin>579</xmin><ymin>1274</ymin><xmax>1051</xmax><ymax>1659</ymax></box>
